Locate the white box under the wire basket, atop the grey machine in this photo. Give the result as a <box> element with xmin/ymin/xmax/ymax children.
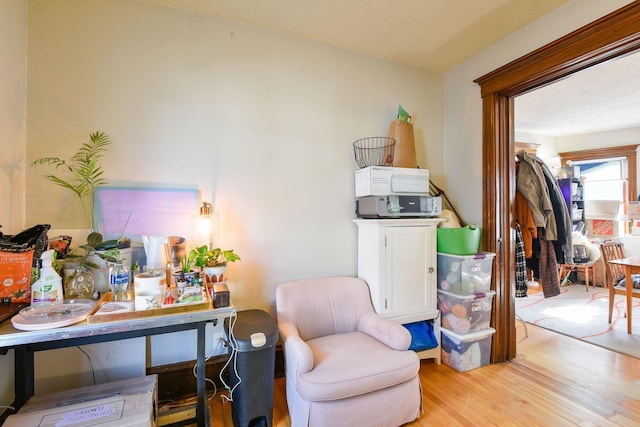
<box><xmin>355</xmin><ymin>166</ymin><xmax>429</xmax><ymax>197</ymax></box>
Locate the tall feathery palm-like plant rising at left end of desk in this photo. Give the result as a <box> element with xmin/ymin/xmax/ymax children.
<box><xmin>31</xmin><ymin>131</ymin><xmax>111</xmax><ymax>231</ymax></box>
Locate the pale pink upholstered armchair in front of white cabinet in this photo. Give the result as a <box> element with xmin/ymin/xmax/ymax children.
<box><xmin>276</xmin><ymin>277</ymin><xmax>421</xmax><ymax>427</ymax></box>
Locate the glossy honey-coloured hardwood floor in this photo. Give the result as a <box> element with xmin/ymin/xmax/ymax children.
<box><xmin>206</xmin><ymin>321</ymin><xmax>640</xmax><ymax>427</ymax></box>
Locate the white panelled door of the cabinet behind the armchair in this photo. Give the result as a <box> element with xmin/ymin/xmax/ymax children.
<box><xmin>385</xmin><ymin>227</ymin><xmax>437</xmax><ymax>321</ymax></box>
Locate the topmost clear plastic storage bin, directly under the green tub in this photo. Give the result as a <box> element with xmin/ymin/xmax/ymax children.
<box><xmin>438</xmin><ymin>252</ymin><xmax>496</xmax><ymax>295</ymax></box>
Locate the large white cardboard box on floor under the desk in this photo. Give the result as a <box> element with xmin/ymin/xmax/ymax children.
<box><xmin>4</xmin><ymin>374</ymin><xmax>158</xmax><ymax>427</ymax></box>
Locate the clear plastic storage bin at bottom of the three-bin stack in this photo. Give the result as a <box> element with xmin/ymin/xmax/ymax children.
<box><xmin>441</xmin><ymin>328</ymin><xmax>496</xmax><ymax>372</ymax></box>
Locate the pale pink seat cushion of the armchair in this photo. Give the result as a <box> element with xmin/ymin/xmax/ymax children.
<box><xmin>297</xmin><ymin>332</ymin><xmax>420</xmax><ymax>401</ymax></box>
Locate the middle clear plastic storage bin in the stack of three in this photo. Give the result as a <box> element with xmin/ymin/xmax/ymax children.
<box><xmin>438</xmin><ymin>290</ymin><xmax>495</xmax><ymax>334</ymax></box>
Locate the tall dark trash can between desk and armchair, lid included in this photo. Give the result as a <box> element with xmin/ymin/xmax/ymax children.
<box><xmin>224</xmin><ymin>310</ymin><xmax>278</xmax><ymax>427</ymax></box>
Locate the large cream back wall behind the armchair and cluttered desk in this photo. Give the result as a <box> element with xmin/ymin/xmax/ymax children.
<box><xmin>0</xmin><ymin>0</ymin><xmax>445</xmax><ymax>403</ymax></box>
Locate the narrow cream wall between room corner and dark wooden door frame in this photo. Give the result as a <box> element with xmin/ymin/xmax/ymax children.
<box><xmin>444</xmin><ymin>0</ymin><xmax>631</xmax><ymax>224</ymax></box>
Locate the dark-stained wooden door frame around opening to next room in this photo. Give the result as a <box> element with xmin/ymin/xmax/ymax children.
<box><xmin>474</xmin><ymin>0</ymin><xmax>640</xmax><ymax>363</ymax></box>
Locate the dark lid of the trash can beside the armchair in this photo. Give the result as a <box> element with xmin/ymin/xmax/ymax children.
<box><xmin>224</xmin><ymin>310</ymin><xmax>278</xmax><ymax>352</ymax></box>
